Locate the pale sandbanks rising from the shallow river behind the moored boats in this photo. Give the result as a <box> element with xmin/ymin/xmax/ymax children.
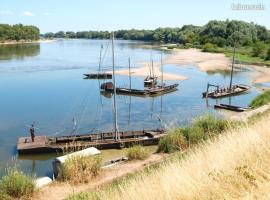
<box><xmin>116</xmin><ymin>49</ymin><xmax>270</xmax><ymax>83</ymax></box>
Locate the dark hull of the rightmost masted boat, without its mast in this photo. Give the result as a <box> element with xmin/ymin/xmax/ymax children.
<box><xmin>203</xmin><ymin>84</ymin><xmax>251</xmax><ymax>99</ymax></box>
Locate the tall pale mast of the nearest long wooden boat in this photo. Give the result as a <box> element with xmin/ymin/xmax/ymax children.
<box><xmin>112</xmin><ymin>32</ymin><xmax>120</xmax><ymax>141</ymax></box>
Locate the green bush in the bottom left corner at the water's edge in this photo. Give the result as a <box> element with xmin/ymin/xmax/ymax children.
<box><xmin>0</xmin><ymin>167</ymin><xmax>35</xmax><ymax>199</ymax></box>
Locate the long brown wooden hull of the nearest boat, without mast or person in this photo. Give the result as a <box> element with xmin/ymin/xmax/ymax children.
<box><xmin>17</xmin><ymin>129</ymin><xmax>165</xmax><ymax>154</ymax></box>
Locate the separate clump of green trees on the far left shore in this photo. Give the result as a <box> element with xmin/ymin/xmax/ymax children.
<box><xmin>0</xmin><ymin>24</ymin><xmax>40</xmax><ymax>42</ymax></box>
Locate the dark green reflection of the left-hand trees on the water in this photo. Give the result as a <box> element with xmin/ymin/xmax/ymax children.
<box><xmin>0</xmin><ymin>44</ymin><xmax>40</xmax><ymax>60</ymax></box>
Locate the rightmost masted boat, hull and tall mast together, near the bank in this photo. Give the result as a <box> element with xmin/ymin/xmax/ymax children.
<box><xmin>202</xmin><ymin>45</ymin><xmax>251</xmax><ymax>99</ymax></box>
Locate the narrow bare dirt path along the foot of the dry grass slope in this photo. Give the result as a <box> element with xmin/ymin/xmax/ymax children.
<box><xmin>32</xmin><ymin>154</ymin><xmax>167</xmax><ymax>200</ymax></box>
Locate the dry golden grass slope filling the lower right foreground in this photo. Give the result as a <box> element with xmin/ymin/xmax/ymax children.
<box><xmin>70</xmin><ymin>115</ymin><xmax>270</xmax><ymax>200</ymax></box>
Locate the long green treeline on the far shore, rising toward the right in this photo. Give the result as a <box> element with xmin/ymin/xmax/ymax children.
<box><xmin>43</xmin><ymin>20</ymin><xmax>270</xmax><ymax>47</ymax></box>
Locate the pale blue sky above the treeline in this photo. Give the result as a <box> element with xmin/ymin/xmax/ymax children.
<box><xmin>0</xmin><ymin>0</ymin><xmax>270</xmax><ymax>33</ymax></box>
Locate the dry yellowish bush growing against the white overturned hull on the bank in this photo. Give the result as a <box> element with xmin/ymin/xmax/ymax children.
<box><xmin>59</xmin><ymin>156</ymin><xmax>102</xmax><ymax>184</ymax></box>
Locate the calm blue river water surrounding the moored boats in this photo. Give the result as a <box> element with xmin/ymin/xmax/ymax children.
<box><xmin>0</xmin><ymin>40</ymin><xmax>258</xmax><ymax>176</ymax></box>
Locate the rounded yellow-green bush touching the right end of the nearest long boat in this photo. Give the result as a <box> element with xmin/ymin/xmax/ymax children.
<box><xmin>158</xmin><ymin>129</ymin><xmax>187</xmax><ymax>153</ymax></box>
